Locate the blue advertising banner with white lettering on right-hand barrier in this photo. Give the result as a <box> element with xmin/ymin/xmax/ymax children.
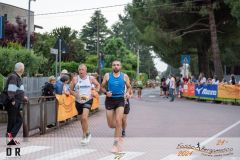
<box><xmin>195</xmin><ymin>84</ymin><xmax>218</xmax><ymax>98</ymax></box>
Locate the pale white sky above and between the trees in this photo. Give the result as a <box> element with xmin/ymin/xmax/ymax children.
<box><xmin>0</xmin><ymin>0</ymin><xmax>166</xmax><ymax>72</ymax></box>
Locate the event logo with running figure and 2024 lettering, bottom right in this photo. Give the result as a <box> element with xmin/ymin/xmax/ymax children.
<box><xmin>176</xmin><ymin>139</ymin><xmax>233</xmax><ymax>157</ymax></box>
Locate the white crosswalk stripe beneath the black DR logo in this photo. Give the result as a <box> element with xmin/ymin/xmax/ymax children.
<box><xmin>0</xmin><ymin>146</ymin><xmax>50</xmax><ymax>160</ymax></box>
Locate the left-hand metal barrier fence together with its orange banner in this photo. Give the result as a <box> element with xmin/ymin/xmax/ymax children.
<box><xmin>23</xmin><ymin>95</ymin><xmax>99</xmax><ymax>137</ymax></box>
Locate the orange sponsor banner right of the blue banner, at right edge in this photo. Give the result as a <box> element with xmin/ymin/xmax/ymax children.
<box><xmin>218</xmin><ymin>84</ymin><xmax>240</xmax><ymax>99</ymax></box>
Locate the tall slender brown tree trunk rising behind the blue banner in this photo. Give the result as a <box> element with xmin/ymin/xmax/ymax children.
<box><xmin>207</xmin><ymin>0</ymin><xmax>223</xmax><ymax>79</ymax></box>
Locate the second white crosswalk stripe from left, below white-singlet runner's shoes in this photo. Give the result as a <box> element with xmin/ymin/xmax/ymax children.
<box><xmin>37</xmin><ymin>149</ymin><xmax>96</xmax><ymax>160</ymax></box>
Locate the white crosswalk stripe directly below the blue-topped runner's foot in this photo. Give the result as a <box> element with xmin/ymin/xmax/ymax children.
<box><xmin>98</xmin><ymin>152</ymin><xmax>144</xmax><ymax>160</ymax></box>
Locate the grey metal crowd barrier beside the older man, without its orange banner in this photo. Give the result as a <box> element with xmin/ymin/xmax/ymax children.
<box><xmin>22</xmin><ymin>96</ymin><xmax>82</xmax><ymax>137</ymax></box>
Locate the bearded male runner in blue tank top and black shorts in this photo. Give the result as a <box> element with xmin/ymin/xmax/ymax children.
<box><xmin>101</xmin><ymin>61</ymin><xmax>131</xmax><ymax>153</ymax></box>
